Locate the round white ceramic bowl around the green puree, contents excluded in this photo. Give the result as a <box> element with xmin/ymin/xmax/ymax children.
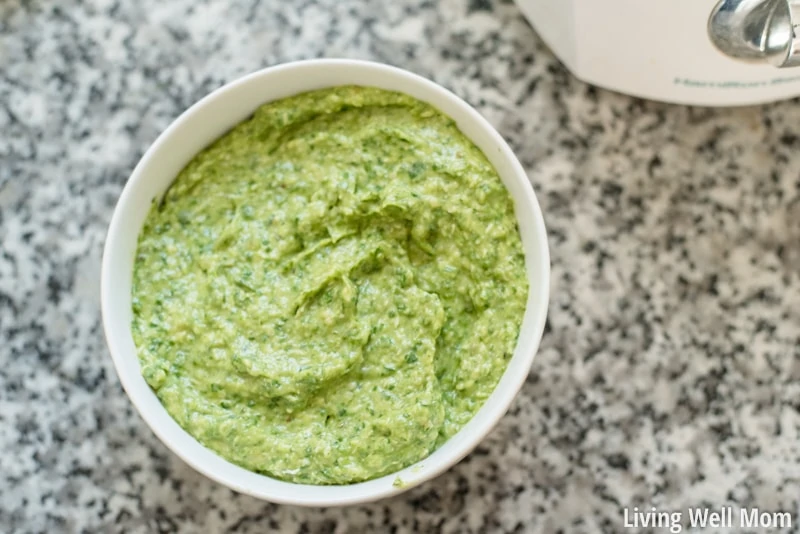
<box><xmin>101</xmin><ymin>59</ymin><xmax>550</xmax><ymax>506</ymax></box>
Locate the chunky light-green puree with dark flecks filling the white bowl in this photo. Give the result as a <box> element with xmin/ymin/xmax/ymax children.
<box><xmin>133</xmin><ymin>86</ymin><xmax>528</xmax><ymax>484</ymax></box>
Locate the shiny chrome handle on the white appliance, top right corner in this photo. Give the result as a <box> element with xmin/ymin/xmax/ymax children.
<box><xmin>708</xmin><ymin>0</ymin><xmax>800</xmax><ymax>68</ymax></box>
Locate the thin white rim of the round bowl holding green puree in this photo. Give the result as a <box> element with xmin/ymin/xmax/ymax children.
<box><xmin>100</xmin><ymin>58</ymin><xmax>550</xmax><ymax>507</ymax></box>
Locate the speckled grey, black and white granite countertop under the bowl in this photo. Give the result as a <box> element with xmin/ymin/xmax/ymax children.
<box><xmin>0</xmin><ymin>0</ymin><xmax>800</xmax><ymax>533</ymax></box>
